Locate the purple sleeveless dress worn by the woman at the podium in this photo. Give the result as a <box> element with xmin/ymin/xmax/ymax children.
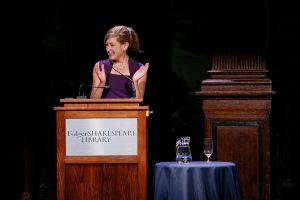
<box><xmin>99</xmin><ymin>58</ymin><xmax>142</xmax><ymax>99</ymax></box>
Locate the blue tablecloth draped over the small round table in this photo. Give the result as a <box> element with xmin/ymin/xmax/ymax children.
<box><xmin>154</xmin><ymin>161</ymin><xmax>242</xmax><ymax>200</ymax></box>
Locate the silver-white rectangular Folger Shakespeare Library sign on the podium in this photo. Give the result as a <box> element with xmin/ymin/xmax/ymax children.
<box><xmin>66</xmin><ymin>118</ymin><xmax>138</xmax><ymax>156</ymax></box>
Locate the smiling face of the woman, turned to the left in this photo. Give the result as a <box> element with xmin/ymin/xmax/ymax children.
<box><xmin>105</xmin><ymin>37</ymin><xmax>128</xmax><ymax>61</ymax></box>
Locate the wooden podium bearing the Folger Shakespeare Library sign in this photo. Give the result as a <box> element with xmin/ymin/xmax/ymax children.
<box><xmin>54</xmin><ymin>99</ymin><xmax>149</xmax><ymax>200</ymax></box>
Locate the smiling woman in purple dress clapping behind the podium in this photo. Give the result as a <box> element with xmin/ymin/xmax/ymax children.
<box><xmin>90</xmin><ymin>25</ymin><xmax>149</xmax><ymax>99</ymax></box>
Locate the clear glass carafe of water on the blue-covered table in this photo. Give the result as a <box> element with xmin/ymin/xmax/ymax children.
<box><xmin>175</xmin><ymin>136</ymin><xmax>192</xmax><ymax>164</ymax></box>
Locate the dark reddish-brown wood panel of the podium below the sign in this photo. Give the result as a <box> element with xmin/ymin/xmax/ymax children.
<box><xmin>65</xmin><ymin>164</ymin><xmax>140</xmax><ymax>200</ymax></box>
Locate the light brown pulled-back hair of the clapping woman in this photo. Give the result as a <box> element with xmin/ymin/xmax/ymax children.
<box><xmin>104</xmin><ymin>25</ymin><xmax>142</xmax><ymax>52</ymax></box>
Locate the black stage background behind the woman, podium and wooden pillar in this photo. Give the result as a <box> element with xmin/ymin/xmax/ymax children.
<box><xmin>1</xmin><ymin>0</ymin><xmax>300</xmax><ymax>200</ymax></box>
